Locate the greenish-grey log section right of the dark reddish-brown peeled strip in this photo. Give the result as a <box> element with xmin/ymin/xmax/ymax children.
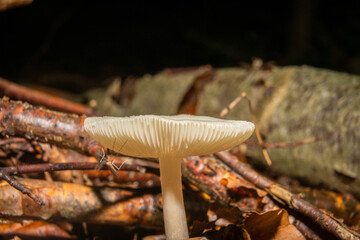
<box><xmin>197</xmin><ymin>66</ymin><xmax>360</xmax><ymax>197</ymax></box>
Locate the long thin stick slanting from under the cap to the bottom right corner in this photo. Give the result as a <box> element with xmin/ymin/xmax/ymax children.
<box><xmin>216</xmin><ymin>152</ymin><xmax>360</xmax><ymax>239</ymax></box>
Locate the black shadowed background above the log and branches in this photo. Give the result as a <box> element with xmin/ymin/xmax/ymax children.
<box><xmin>0</xmin><ymin>0</ymin><xmax>360</xmax><ymax>92</ymax></box>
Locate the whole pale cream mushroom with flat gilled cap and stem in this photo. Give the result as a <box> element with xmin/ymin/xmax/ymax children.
<box><xmin>84</xmin><ymin>115</ymin><xmax>254</xmax><ymax>239</ymax></box>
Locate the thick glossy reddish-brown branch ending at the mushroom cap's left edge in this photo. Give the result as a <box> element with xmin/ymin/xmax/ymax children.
<box><xmin>0</xmin><ymin>98</ymin><xmax>103</xmax><ymax>156</ymax></box>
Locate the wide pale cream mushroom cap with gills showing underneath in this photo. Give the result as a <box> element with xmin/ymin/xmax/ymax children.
<box><xmin>84</xmin><ymin>115</ymin><xmax>255</xmax><ymax>158</ymax></box>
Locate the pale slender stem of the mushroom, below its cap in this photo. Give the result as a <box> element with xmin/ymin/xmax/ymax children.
<box><xmin>159</xmin><ymin>157</ymin><xmax>189</xmax><ymax>240</ymax></box>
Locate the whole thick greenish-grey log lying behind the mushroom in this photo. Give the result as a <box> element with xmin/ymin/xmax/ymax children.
<box><xmin>89</xmin><ymin>66</ymin><xmax>360</xmax><ymax>197</ymax></box>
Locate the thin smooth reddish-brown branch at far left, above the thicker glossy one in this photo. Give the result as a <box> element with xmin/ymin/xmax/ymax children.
<box><xmin>0</xmin><ymin>77</ymin><xmax>95</xmax><ymax>115</ymax></box>
